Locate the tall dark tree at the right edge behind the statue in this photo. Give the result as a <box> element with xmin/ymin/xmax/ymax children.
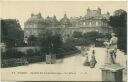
<box><xmin>109</xmin><ymin>9</ymin><xmax>127</xmax><ymax>52</ymax></box>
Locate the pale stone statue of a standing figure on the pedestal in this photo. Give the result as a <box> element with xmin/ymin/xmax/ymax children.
<box><xmin>104</xmin><ymin>33</ymin><xmax>118</xmax><ymax>64</ymax></box>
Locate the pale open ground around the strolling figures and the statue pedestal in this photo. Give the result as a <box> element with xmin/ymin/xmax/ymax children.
<box><xmin>1</xmin><ymin>48</ymin><xmax>126</xmax><ymax>81</ymax></box>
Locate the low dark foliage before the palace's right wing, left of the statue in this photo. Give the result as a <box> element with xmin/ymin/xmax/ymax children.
<box><xmin>70</xmin><ymin>31</ymin><xmax>105</xmax><ymax>46</ymax></box>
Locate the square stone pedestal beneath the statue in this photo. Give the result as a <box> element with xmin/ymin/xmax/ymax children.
<box><xmin>101</xmin><ymin>64</ymin><xmax>124</xmax><ymax>82</ymax></box>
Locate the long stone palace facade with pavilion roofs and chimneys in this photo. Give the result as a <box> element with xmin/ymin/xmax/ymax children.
<box><xmin>24</xmin><ymin>8</ymin><xmax>112</xmax><ymax>38</ymax></box>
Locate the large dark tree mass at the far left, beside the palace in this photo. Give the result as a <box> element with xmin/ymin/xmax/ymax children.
<box><xmin>1</xmin><ymin>19</ymin><xmax>24</xmax><ymax>47</ymax></box>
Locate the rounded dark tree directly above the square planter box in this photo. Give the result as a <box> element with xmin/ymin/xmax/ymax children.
<box><xmin>39</xmin><ymin>29</ymin><xmax>63</xmax><ymax>54</ymax></box>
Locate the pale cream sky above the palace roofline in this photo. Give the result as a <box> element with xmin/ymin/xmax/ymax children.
<box><xmin>0</xmin><ymin>1</ymin><xmax>127</xmax><ymax>28</ymax></box>
